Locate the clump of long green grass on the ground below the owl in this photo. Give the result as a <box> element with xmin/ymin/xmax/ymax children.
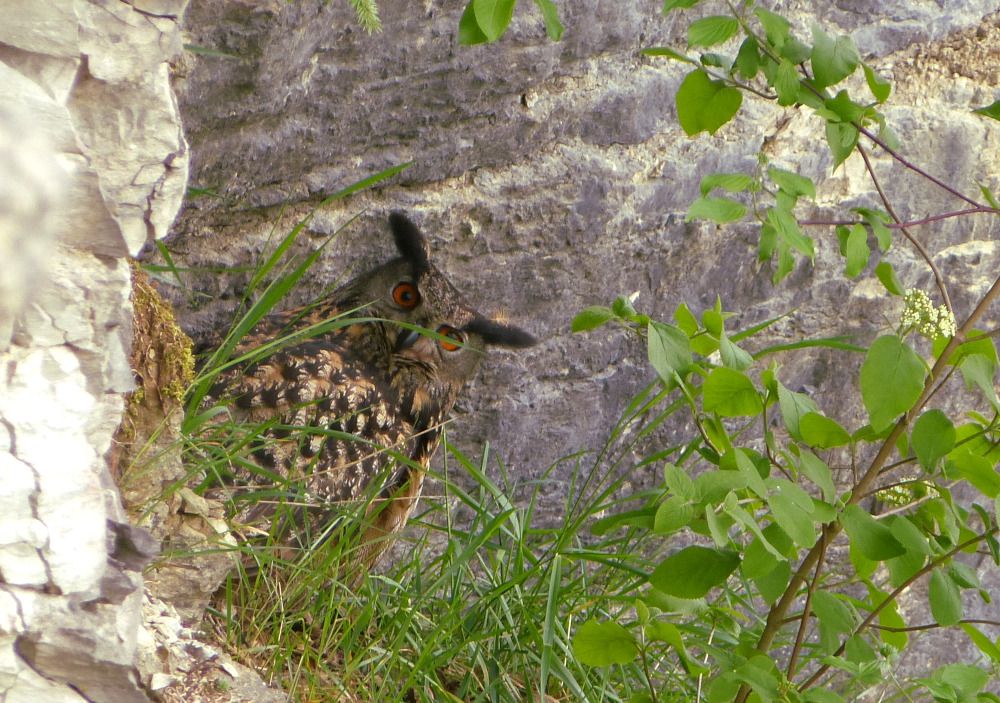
<box><xmin>204</xmin><ymin>428</ymin><xmax>668</xmax><ymax>701</ymax></box>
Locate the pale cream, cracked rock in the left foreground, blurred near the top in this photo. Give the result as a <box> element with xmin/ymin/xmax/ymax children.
<box><xmin>0</xmin><ymin>0</ymin><xmax>187</xmax><ymax>703</ymax></box>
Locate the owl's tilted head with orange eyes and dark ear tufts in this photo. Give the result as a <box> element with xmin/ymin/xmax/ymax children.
<box><xmin>344</xmin><ymin>212</ymin><xmax>535</xmax><ymax>395</ymax></box>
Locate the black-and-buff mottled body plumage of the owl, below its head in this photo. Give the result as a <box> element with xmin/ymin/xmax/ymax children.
<box><xmin>209</xmin><ymin>310</ymin><xmax>453</xmax><ymax>531</ymax></box>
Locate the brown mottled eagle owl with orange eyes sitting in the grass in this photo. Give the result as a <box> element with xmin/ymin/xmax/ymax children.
<box><xmin>209</xmin><ymin>213</ymin><xmax>535</xmax><ymax>567</ymax></box>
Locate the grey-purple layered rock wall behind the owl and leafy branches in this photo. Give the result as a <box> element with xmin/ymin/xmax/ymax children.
<box><xmin>170</xmin><ymin>0</ymin><xmax>1000</xmax><ymax>688</ymax></box>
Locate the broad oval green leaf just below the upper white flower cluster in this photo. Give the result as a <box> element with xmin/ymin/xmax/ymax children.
<box><xmin>861</xmin><ymin>335</ymin><xmax>927</xmax><ymax>432</ymax></box>
